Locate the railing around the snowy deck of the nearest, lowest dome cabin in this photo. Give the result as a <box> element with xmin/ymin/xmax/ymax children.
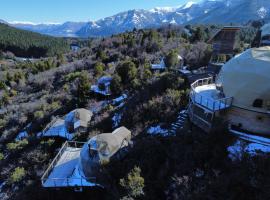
<box><xmin>41</xmin><ymin>141</ymin><xmax>96</xmax><ymax>187</ymax></box>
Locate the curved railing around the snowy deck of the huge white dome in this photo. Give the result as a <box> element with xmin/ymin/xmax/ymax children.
<box><xmin>190</xmin><ymin>77</ymin><xmax>233</xmax><ymax>112</ymax></box>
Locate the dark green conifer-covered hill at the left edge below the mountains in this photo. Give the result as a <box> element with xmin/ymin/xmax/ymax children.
<box><xmin>0</xmin><ymin>23</ymin><xmax>69</xmax><ymax>58</ymax></box>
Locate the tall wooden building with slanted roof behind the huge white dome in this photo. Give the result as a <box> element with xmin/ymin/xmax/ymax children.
<box><xmin>208</xmin><ymin>26</ymin><xmax>240</xmax><ymax>73</ymax></box>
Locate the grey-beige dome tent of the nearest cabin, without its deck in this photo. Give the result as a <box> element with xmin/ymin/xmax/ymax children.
<box><xmin>79</xmin><ymin>127</ymin><xmax>131</xmax><ymax>179</ymax></box>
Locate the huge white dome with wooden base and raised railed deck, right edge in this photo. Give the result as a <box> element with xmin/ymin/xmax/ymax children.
<box><xmin>188</xmin><ymin>47</ymin><xmax>270</xmax><ymax>135</ymax></box>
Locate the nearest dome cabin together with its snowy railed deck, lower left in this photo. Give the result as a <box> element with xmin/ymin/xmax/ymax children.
<box><xmin>41</xmin><ymin>127</ymin><xmax>131</xmax><ymax>191</ymax></box>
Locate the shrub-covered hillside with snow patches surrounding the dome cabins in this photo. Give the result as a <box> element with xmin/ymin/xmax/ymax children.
<box><xmin>0</xmin><ymin>25</ymin><xmax>270</xmax><ymax>200</ymax></box>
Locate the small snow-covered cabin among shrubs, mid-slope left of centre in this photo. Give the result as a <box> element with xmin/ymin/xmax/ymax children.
<box><xmin>91</xmin><ymin>76</ymin><xmax>112</xmax><ymax>96</ymax></box>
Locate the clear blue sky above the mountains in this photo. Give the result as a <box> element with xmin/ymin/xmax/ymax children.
<box><xmin>0</xmin><ymin>0</ymin><xmax>198</xmax><ymax>23</ymax></box>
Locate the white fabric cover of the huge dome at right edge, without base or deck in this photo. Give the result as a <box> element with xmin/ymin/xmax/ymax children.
<box><xmin>216</xmin><ymin>47</ymin><xmax>270</xmax><ymax>111</ymax></box>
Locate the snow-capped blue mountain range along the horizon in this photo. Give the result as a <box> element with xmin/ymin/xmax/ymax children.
<box><xmin>0</xmin><ymin>0</ymin><xmax>270</xmax><ymax>37</ymax></box>
